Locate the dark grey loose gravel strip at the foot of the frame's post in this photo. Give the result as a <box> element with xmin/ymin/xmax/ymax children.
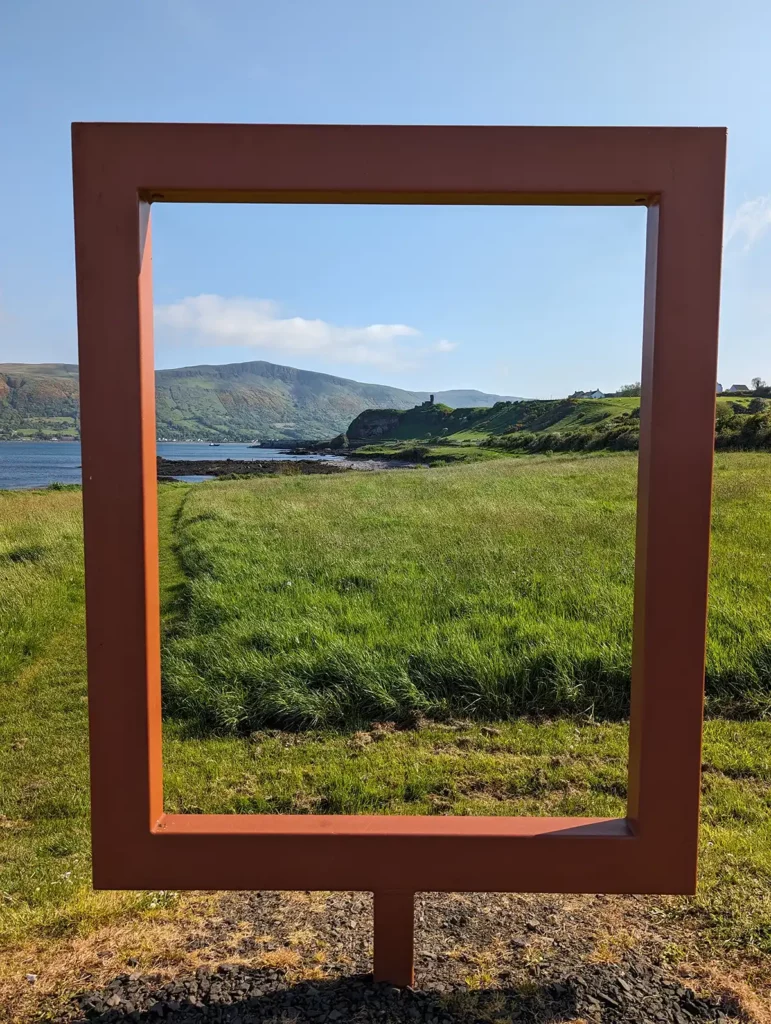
<box><xmin>60</xmin><ymin>963</ymin><xmax>729</xmax><ymax>1024</ymax></box>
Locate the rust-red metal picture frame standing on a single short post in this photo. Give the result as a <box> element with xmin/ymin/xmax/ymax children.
<box><xmin>73</xmin><ymin>124</ymin><xmax>726</xmax><ymax>982</ymax></box>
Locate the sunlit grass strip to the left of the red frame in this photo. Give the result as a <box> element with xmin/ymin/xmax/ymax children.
<box><xmin>0</xmin><ymin>488</ymin><xmax>166</xmax><ymax>944</ymax></box>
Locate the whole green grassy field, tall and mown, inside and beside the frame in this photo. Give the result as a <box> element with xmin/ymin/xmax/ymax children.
<box><xmin>0</xmin><ymin>454</ymin><xmax>771</xmax><ymax>981</ymax></box>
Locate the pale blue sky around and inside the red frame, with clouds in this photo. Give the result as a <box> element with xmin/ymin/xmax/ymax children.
<box><xmin>0</xmin><ymin>0</ymin><xmax>771</xmax><ymax>397</ymax></box>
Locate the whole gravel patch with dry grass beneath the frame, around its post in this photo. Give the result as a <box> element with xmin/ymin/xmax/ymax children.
<box><xmin>45</xmin><ymin>893</ymin><xmax>735</xmax><ymax>1024</ymax></box>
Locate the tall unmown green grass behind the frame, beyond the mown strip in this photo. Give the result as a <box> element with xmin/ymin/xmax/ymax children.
<box><xmin>164</xmin><ymin>454</ymin><xmax>771</xmax><ymax>732</ymax></box>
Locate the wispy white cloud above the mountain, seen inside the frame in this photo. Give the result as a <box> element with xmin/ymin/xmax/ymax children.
<box><xmin>155</xmin><ymin>295</ymin><xmax>458</xmax><ymax>370</ymax></box>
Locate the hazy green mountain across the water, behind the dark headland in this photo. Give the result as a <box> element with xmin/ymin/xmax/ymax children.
<box><xmin>0</xmin><ymin>361</ymin><xmax>520</xmax><ymax>440</ymax></box>
